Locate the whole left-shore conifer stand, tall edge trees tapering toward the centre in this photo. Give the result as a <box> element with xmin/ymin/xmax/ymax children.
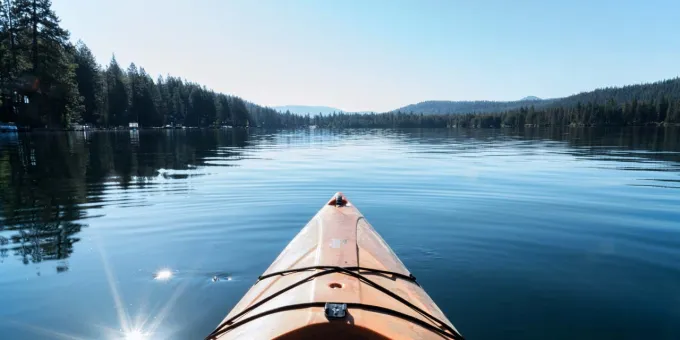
<box><xmin>0</xmin><ymin>0</ymin><xmax>304</xmax><ymax>127</ymax></box>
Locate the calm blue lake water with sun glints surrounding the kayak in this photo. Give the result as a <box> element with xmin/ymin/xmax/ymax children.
<box><xmin>0</xmin><ymin>128</ymin><xmax>680</xmax><ymax>340</ymax></box>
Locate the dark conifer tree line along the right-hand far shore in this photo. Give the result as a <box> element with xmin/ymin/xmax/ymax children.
<box><xmin>313</xmin><ymin>78</ymin><xmax>680</xmax><ymax>128</ymax></box>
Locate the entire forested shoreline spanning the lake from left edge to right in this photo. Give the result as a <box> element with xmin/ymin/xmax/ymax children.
<box><xmin>0</xmin><ymin>0</ymin><xmax>680</xmax><ymax>129</ymax></box>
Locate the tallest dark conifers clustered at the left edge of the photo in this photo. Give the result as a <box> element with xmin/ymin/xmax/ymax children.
<box><xmin>0</xmin><ymin>0</ymin><xmax>83</xmax><ymax>126</ymax></box>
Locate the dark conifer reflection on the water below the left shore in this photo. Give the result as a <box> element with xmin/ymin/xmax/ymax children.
<box><xmin>0</xmin><ymin>130</ymin><xmax>248</xmax><ymax>273</ymax></box>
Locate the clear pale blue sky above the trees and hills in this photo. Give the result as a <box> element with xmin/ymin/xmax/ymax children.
<box><xmin>53</xmin><ymin>0</ymin><xmax>680</xmax><ymax>111</ymax></box>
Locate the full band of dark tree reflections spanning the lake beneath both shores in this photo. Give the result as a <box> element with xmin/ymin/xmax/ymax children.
<box><xmin>0</xmin><ymin>128</ymin><xmax>680</xmax><ymax>273</ymax></box>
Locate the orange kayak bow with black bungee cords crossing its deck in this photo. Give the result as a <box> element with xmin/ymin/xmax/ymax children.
<box><xmin>206</xmin><ymin>193</ymin><xmax>463</xmax><ymax>340</ymax></box>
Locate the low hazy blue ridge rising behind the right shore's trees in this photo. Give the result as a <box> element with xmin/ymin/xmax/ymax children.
<box><xmin>394</xmin><ymin>96</ymin><xmax>555</xmax><ymax>114</ymax></box>
